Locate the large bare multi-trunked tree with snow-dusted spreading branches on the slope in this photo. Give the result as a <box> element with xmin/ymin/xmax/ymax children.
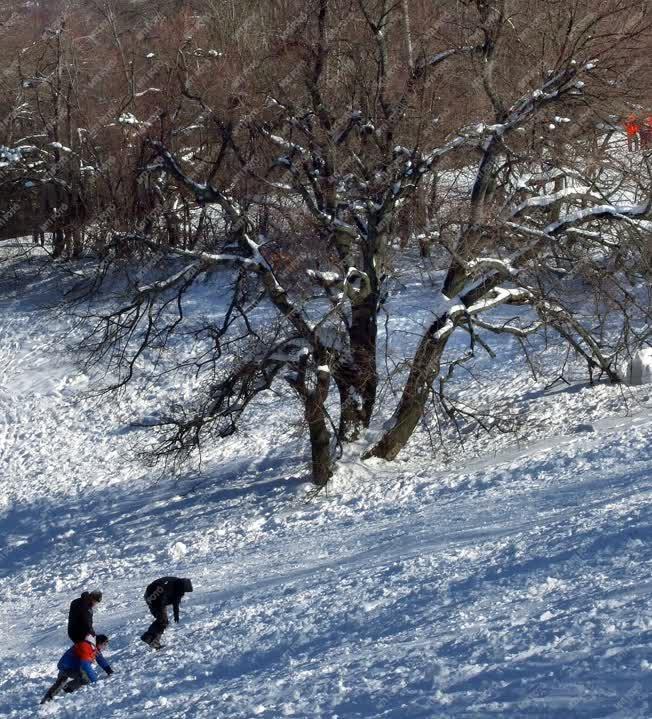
<box><xmin>61</xmin><ymin>0</ymin><xmax>651</xmax><ymax>485</ymax></box>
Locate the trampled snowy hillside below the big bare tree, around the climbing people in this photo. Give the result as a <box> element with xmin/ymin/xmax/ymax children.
<box><xmin>0</xmin><ymin>268</ymin><xmax>652</xmax><ymax>719</ymax></box>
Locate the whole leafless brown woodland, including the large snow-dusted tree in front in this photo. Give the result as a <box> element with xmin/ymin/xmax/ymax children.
<box><xmin>0</xmin><ymin>0</ymin><xmax>652</xmax><ymax>486</ymax></box>
